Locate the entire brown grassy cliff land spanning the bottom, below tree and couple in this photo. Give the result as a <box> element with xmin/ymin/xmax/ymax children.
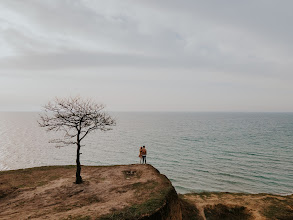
<box><xmin>0</xmin><ymin>165</ymin><xmax>293</xmax><ymax>220</ymax></box>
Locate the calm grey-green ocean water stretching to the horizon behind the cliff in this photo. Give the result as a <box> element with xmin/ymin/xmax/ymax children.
<box><xmin>0</xmin><ymin>112</ymin><xmax>293</xmax><ymax>194</ymax></box>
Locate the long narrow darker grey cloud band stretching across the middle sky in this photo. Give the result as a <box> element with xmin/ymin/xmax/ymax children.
<box><xmin>0</xmin><ymin>51</ymin><xmax>291</xmax><ymax>82</ymax></box>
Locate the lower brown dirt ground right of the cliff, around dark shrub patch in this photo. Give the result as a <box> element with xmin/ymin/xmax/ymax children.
<box><xmin>181</xmin><ymin>192</ymin><xmax>293</xmax><ymax>220</ymax></box>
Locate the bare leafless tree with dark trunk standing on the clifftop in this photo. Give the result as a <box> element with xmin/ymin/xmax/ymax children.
<box><xmin>38</xmin><ymin>97</ymin><xmax>115</xmax><ymax>184</ymax></box>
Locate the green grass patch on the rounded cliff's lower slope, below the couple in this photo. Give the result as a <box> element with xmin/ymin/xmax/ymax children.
<box><xmin>99</xmin><ymin>187</ymin><xmax>172</xmax><ymax>220</ymax></box>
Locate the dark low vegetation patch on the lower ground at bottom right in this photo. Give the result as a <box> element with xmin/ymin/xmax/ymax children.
<box><xmin>204</xmin><ymin>204</ymin><xmax>251</xmax><ymax>220</ymax></box>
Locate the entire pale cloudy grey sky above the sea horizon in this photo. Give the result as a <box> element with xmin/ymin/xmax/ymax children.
<box><xmin>0</xmin><ymin>0</ymin><xmax>293</xmax><ymax>112</ymax></box>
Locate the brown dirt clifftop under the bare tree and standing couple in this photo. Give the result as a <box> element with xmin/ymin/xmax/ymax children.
<box><xmin>0</xmin><ymin>165</ymin><xmax>170</xmax><ymax>219</ymax></box>
